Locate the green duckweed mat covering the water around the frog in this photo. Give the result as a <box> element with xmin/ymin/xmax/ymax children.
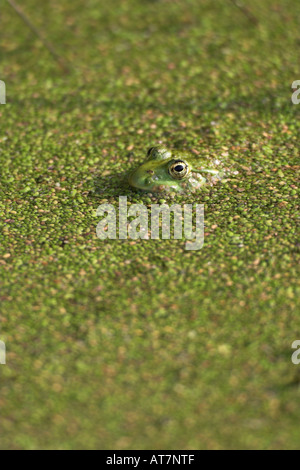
<box><xmin>0</xmin><ymin>0</ymin><xmax>300</xmax><ymax>450</ymax></box>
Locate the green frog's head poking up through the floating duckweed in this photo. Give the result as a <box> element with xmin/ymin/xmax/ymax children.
<box><xmin>128</xmin><ymin>145</ymin><xmax>224</xmax><ymax>193</ymax></box>
